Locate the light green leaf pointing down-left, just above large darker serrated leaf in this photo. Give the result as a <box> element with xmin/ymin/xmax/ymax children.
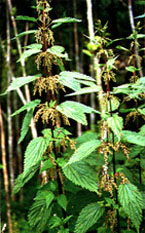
<box><xmin>66</xmin><ymin>140</ymin><xmax>101</xmax><ymax>165</ymax></box>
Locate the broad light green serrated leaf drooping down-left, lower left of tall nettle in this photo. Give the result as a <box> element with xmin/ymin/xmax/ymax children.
<box><xmin>24</xmin><ymin>137</ymin><xmax>50</xmax><ymax>171</ymax></box>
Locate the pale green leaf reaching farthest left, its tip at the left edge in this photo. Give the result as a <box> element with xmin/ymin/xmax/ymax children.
<box><xmin>1</xmin><ymin>74</ymin><xmax>41</xmax><ymax>95</ymax></box>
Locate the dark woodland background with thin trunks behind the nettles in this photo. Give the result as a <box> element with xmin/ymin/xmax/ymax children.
<box><xmin>0</xmin><ymin>0</ymin><xmax>145</xmax><ymax>233</ymax></box>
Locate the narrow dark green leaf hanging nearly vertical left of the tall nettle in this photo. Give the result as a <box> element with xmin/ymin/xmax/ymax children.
<box><xmin>18</xmin><ymin>109</ymin><xmax>33</xmax><ymax>144</ymax></box>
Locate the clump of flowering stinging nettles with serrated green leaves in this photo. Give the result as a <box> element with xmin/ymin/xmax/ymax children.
<box><xmin>1</xmin><ymin>0</ymin><xmax>145</xmax><ymax>233</ymax></box>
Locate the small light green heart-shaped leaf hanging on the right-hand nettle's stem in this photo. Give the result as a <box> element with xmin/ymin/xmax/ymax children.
<box><xmin>107</xmin><ymin>114</ymin><xmax>123</xmax><ymax>141</ymax></box>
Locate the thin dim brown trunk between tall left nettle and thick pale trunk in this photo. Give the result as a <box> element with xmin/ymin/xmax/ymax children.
<box><xmin>73</xmin><ymin>0</ymin><xmax>82</xmax><ymax>136</ymax></box>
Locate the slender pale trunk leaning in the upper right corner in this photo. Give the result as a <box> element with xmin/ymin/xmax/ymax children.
<box><xmin>128</xmin><ymin>0</ymin><xmax>143</xmax><ymax>77</ymax></box>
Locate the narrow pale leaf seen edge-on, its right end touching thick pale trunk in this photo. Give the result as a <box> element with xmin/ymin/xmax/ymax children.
<box><xmin>65</xmin><ymin>85</ymin><xmax>101</xmax><ymax>96</ymax></box>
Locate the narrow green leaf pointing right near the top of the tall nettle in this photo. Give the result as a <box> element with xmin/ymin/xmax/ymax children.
<box><xmin>52</xmin><ymin>17</ymin><xmax>81</xmax><ymax>28</ymax></box>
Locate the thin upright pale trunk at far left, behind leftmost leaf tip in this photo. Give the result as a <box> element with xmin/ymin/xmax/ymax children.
<box><xmin>6</xmin><ymin>5</ymin><xmax>15</xmax><ymax>200</ymax></box>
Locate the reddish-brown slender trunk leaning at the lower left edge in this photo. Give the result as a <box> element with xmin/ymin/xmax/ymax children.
<box><xmin>0</xmin><ymin>105</ymin><xmax>13</xmax><ymax>233</ymax></box>
